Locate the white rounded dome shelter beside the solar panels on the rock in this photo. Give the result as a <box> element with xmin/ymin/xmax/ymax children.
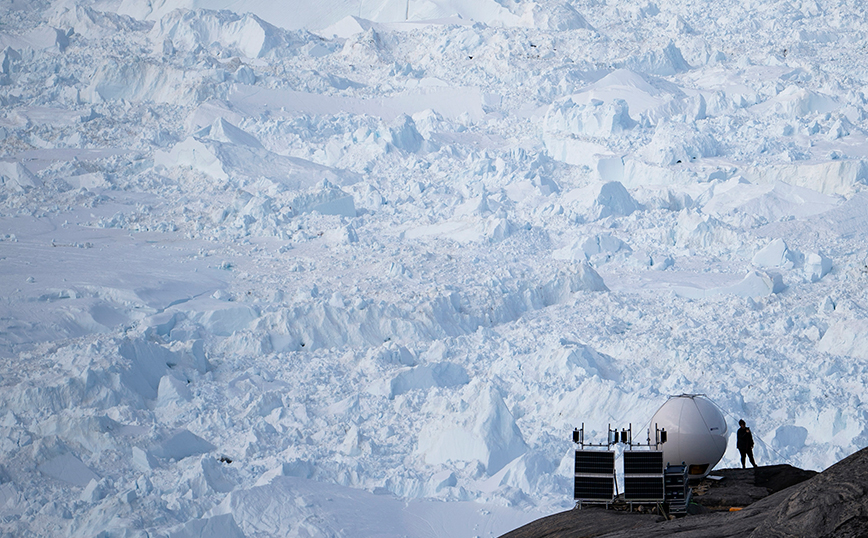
<box><xmin>651</xmin><ymin>394</ymin><xmax>727</xmax><ymax>478</ymax></box>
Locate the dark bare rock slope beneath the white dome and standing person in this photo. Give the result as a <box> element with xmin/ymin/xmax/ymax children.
<box><xmin>503</xmin><ymin>449</ymin><xmax>868</xmax><ymax>538</ymax></box>
